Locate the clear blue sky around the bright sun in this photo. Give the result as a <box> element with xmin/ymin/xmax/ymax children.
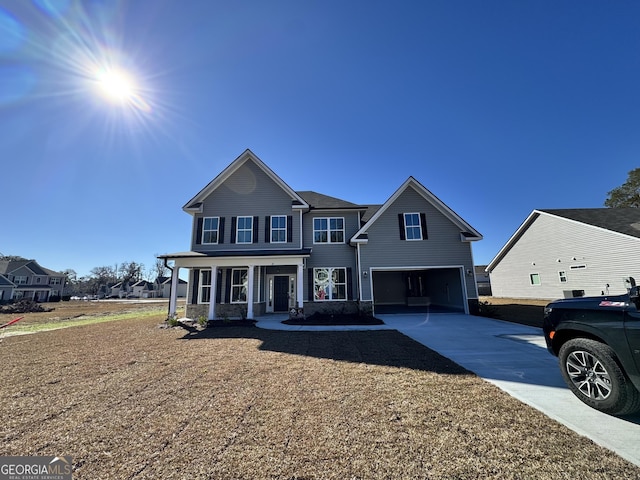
<box><xmin>0</xmin><ymin>0</ymin><xmax>640</xmax><ymax>275</ymax></box>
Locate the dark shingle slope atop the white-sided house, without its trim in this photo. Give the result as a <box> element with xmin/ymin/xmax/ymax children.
<box><xmin>540</xmin><ymin>207</ymin><xmax>640</xmax><ymax>238</ymax></box>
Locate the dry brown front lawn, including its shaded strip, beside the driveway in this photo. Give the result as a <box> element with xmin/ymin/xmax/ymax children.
<box><xmin>0</xmin><ymin>306</ymin><xmax>640</xmax><ymax>480</ymax></box>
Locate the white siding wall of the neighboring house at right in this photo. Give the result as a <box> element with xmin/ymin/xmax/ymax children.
<box><xmin>491</xmin><ymin>215</ymin><xmax>640</xmax><ymax>299</ymax></box>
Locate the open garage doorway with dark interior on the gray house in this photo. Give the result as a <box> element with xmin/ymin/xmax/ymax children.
<box><xmin>372</xmin><ymin>268</ymin><xmax>466</xmax><ymax>314</ymax></box>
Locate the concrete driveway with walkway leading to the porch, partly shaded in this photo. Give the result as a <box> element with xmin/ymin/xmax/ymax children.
<box><xmin>257</xmin><ymin>314</ymin><xmax>640</xmax><ymax>466</ymax></box>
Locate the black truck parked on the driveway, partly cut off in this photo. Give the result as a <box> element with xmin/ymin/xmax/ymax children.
<box><xmin>542</xmin><ymin>282</ymin><xmax>640</xmax><ymax>415</ymax></box>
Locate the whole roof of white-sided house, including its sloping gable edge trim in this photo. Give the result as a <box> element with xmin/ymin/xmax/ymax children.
<box><xmin>487</xmin><ymin>207</ymin><xmax>640</xmax><ymax>272</ymax></box>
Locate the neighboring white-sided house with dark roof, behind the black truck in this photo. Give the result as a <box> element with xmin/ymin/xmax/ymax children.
<box><xmin>487</xmin><ymin>208</ymin><xmax>640</xmax><ymax>299</ymax></box>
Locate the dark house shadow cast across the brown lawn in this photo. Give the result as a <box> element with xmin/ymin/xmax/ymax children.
<box><xmin>181</xmin><ymin>326</ymin><xmax>473</xmax><ymax>375</ymax></box>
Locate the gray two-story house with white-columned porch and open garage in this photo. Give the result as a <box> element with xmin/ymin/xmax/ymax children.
<box><xmin>160</xmin><ymin>150</ymin><xmax>482</xmax><ymax>319</ymax></box>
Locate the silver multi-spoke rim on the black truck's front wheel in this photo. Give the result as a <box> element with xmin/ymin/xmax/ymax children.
<box><xmin>566</xmin><ymin>350</ymin><xmax>611</xmax><ymax>400</ymax></box>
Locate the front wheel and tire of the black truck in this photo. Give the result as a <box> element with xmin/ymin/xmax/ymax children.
<box><xmin>558</xmin><ymin>338</ymin><xmax>640</xmax><ymax>415</ymax></box>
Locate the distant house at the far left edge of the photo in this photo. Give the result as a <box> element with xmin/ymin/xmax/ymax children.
<box><xmin>0</xmin><ymin>260</ymin><xmax>66</xmax><ymax>302</ymax></box>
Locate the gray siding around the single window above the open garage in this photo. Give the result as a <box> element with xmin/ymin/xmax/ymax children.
<box><xmin>360</xmin><ymin>188</ymin><xmax>477</xmax><ymax>300</ymax></box>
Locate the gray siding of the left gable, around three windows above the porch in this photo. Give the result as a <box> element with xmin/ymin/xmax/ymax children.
<box><xmin>191</xmin><ymin>161</ymin><xmax>300</xmax><ymax>252</ymax></box>
